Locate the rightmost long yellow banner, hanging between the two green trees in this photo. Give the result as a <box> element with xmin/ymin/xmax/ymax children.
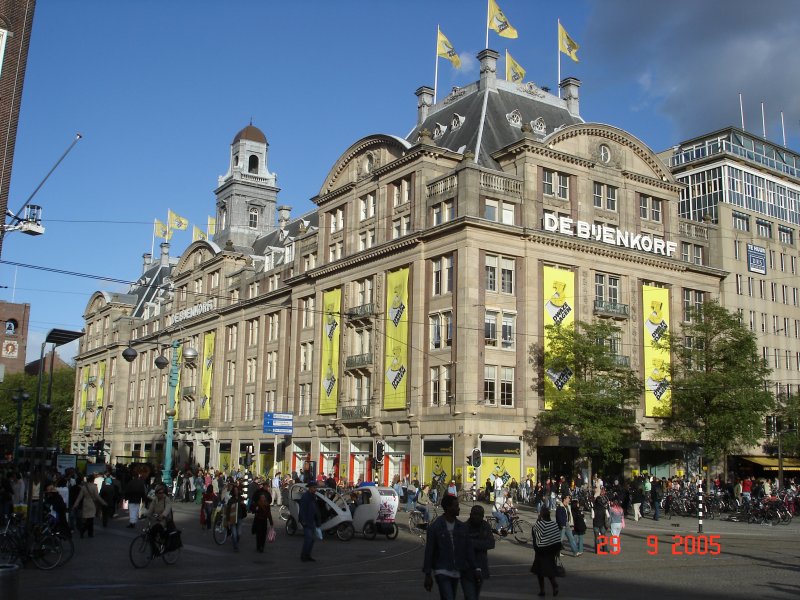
<box><xmin>642</xmin><ymin>285</ymin><xmax>672</xmax><ymax>417</ymax></box>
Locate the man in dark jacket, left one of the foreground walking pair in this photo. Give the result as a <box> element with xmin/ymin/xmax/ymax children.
<box><xmin>422</xmin><ymin>495</ymin><xmax>482</xmax><ymax>599</ymax></box>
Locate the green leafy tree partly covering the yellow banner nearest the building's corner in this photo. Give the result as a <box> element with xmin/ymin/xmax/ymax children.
<box><xmin>530</xmin><ymin>320</ymin><xmax>643</xmax><ymax>462</ymax></box>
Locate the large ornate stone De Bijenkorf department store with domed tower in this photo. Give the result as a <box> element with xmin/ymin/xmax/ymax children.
<box><xmin>73</xmin><ymin>50</ymin><xmax>725</xmax><ymax>483</ymax></box>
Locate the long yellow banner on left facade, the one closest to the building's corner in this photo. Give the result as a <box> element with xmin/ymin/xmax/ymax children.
<box><xmin>383</xmin><ymin>267</ymin><xmax>408</xmax><ymax>410</ymax></box>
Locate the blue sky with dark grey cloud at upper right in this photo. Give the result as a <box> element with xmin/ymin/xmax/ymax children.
<box><xmin>0</xmin><ymin>0</ymin><xmax>800</xmax><ymax>359</ymax></box>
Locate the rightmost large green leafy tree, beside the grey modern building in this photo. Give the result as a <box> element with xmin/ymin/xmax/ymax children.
<box><xmin>656</xmin><ymin>301</ymin><xmax>773</xmax><ymax>478</ymax></box>
